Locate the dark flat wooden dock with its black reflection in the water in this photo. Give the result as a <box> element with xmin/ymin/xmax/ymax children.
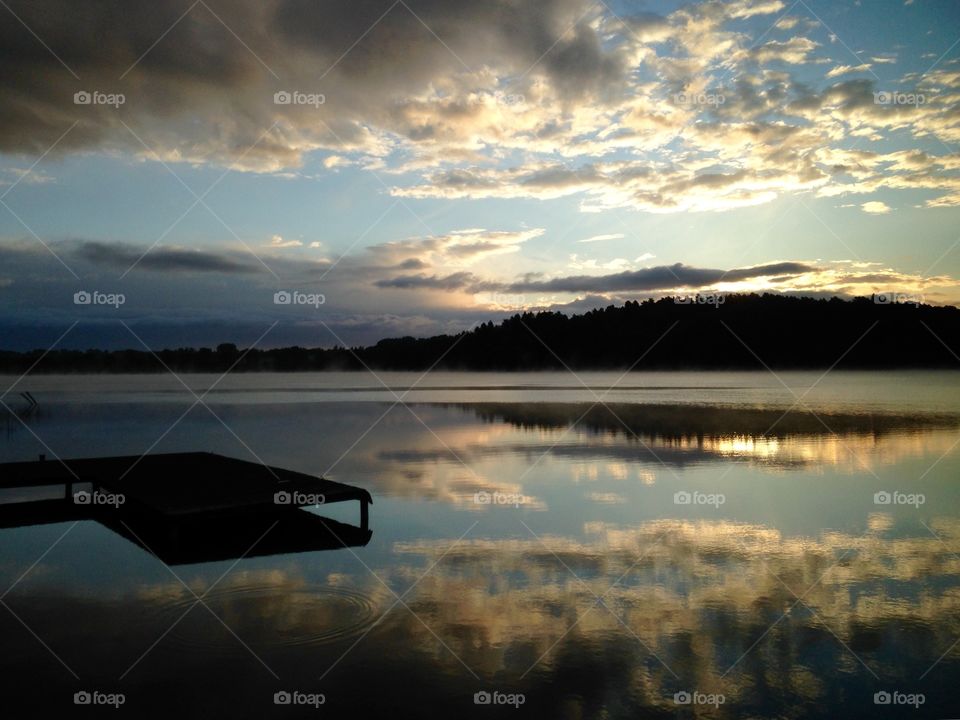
<box><xmin>0</xmin><ymin>453</ymin><xmax>373</xmax><ymax>564</ymax></box>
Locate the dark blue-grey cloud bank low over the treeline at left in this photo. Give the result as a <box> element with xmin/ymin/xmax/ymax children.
<box><xmin>0</xmin><ymin>240</ymin><xmax>502</xmax><ymax>350</ymax></box>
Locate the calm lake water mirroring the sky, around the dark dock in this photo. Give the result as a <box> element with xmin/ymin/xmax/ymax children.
<box><xmin>0</xmin><ymin>372</ymin><xmax>960</xmax><ymax>718</ymax></box>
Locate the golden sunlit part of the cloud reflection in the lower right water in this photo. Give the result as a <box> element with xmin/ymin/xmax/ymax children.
<box><xmin>395</xmin><ymin>514</ymin><xmax>960</xmax><ymax>664</ymax></box>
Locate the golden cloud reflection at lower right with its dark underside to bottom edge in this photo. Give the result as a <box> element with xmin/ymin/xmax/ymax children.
<box><xmin>397</xmin><ymin>514</ymin><xmax>960</xmax><ymax>717</ymax></box>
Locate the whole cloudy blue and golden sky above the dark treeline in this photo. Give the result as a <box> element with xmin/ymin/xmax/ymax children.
<box><xmin>0</xmin><ymin>0</ymin><xmax>960</xmax><ymax>350</ymax></box>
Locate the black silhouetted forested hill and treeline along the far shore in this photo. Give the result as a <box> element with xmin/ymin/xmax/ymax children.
<box><xmin>0</xmin><ymin>294</ymin><xmax>960</xmax><ymax>373</ymax></box>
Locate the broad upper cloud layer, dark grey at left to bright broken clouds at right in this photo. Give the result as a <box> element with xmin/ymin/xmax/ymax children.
<box><xmin>0</xmin><ymin>0</ymin><xmax>960</xmax><ymax>213</ymax></box>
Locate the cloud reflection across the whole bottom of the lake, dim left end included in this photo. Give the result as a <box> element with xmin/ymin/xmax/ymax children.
<box><xmin>8</xmin><ymin>514</ymin><xmax>960</xmax><ymax>717</ymax></box>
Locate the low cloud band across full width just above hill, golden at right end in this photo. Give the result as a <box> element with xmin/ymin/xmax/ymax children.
<box><xmin>0</xmin><ymin>235</ymin><xmax>960</xmax><ymax>349</ymax></box>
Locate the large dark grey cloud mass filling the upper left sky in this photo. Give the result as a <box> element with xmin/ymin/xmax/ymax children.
<box><xmin>0</xmin><ymin>0</ymin><xmax>628</xmax><ymax>163</ymax></box>
